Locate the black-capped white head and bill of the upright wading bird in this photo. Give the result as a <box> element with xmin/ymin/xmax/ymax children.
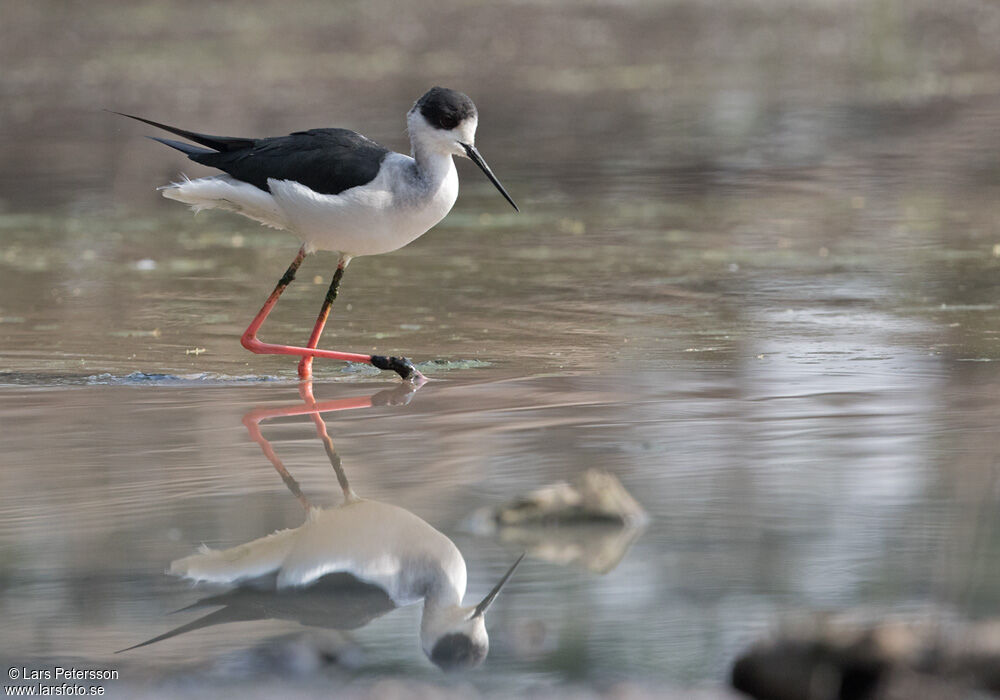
<box><xmin>406</xmin><ymin>87</ymin><xmax>519</xmax><ymax>211</ymax></box>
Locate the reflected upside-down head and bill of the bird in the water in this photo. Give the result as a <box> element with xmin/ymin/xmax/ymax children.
<box><xmin>420</xmin><ymin>554</ymin><xmax>524</xmax><ymax>671</ymax></box>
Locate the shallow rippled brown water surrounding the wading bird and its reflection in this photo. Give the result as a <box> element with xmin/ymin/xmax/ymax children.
<box><xmin>0</xmin><ymin>3</ymin><xmax>1000</xmax><ymax>697</ymax></box>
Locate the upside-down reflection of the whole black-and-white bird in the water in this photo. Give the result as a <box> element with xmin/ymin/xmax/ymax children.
<box><xmin>123</xmin><ymin>382</ymin><xmax>524</xmax><ymax>670</ymax></box>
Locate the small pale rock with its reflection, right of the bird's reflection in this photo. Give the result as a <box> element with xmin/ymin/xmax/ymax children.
<box><xmin>468</xmin><ymin>469</ymin><xmax>648</xmax><ymax>573</ymax></box>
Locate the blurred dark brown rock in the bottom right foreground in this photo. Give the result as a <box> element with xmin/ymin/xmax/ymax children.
<box><xmin>731</xmin><ymin>617</ymin><xmax>1000</xmax><ymax>700</ymax></box>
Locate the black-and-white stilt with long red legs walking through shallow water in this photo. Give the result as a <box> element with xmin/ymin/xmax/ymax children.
<box><xmin>116</xmin><ymin>87</ymin><xmax>517</xmax><ymax>383</ymax></box>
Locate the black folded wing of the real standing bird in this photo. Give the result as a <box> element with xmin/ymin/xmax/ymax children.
<box><xmin>116</xmin><ymin>112</ymin><xmax>389</xmax><ymax>194</ymax></box>
